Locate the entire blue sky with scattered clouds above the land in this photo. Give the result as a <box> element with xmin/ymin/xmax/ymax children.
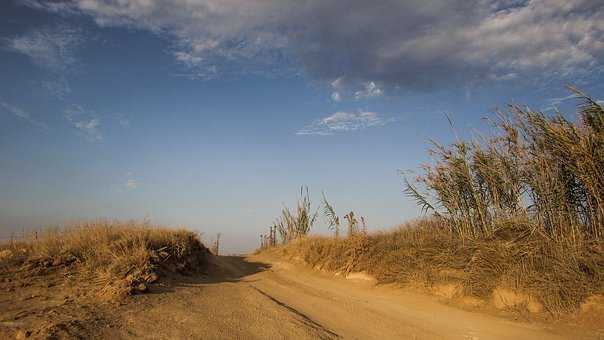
<box><xmin>0</xmin><ymin>0</ymin><xmax>604</xmax><ymax>252</ymax></box>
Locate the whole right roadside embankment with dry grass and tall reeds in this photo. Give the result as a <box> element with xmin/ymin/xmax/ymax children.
<box><xmin>262</xmin><ymin>90</ymin><xmax>604</xmax><ymax>315</ymax></box>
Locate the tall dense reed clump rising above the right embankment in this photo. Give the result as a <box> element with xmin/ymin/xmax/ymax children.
<box><xmin>406</xmin><ymin>88</ymin><xmax>604</xmax><ymax>245</ymax></box>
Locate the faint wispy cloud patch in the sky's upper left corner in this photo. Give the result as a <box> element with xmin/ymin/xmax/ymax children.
<box><xmin>5</xmin><ymin>26</ymin><xmax>84</xmax><ymax>72</ymax></box>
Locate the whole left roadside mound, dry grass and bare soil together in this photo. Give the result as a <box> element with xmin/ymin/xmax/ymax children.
<box><xmin>0</xmin><ymin>223</ymin><xmax>212</xmax><ymax>339</ymax></box>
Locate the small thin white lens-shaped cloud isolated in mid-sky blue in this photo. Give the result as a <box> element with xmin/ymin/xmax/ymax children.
<box><xmin>296</xmin><ymin>111</ymin><xmax>394</xmax><ymax>135</ymax></box>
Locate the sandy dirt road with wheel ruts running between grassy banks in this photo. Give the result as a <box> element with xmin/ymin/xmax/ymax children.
<box><xmin>96</xmin><ymin>256</ymin><xmax>592</xmax><ymax>340</ymax></box>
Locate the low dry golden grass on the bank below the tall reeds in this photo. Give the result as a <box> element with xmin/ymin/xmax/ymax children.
<box><xmin>274</xmin><ymin>219</ymin><xmax>604</xmax><ymax>315</ymax></box>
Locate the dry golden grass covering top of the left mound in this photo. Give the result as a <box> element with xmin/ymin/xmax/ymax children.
<box><xmin>0</xmin><ymin>221</ymin><xmax>207</xmax><ymax>297</ymax></box>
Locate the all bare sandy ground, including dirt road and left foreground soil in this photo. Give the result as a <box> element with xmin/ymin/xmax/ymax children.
<box><xmin>0</xmin><ymin>256</ymin><xmax>602</xmax><ymax>340</ymax></box>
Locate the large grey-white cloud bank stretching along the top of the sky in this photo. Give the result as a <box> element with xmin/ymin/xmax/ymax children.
<box><xmin>23</xmin><ymin>0</ymin><xmax>604</xmax><ymax>93</ymax></box>
